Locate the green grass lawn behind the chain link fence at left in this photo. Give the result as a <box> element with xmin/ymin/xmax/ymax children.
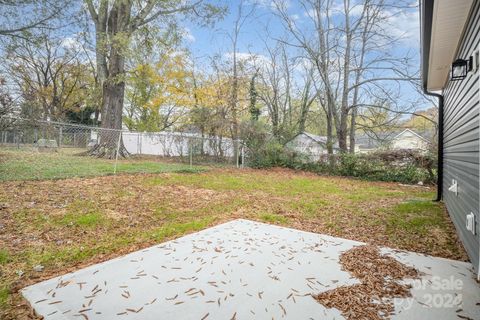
<box><xmin>0</xmin><ymin>148</ymin><xmax>202</xmax><ymax>181</ymax></box>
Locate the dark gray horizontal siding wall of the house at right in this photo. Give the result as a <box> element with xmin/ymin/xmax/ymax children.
<box><xmin>443</xmin><ymin>1</ymin><xmax>480</xmax><ymax>272</ymax></box>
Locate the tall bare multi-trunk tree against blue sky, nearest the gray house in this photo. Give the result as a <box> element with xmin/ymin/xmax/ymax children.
<box><xmin>274</xmin><ymin>0</ymin><xmax>412</xmax><ymax>153</ymax></box>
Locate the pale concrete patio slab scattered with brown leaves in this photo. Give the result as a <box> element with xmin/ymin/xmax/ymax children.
<box><xmin>22</xmin><ymin>220</ymin><xmax>480</xmax><ymax>320</ymax></box>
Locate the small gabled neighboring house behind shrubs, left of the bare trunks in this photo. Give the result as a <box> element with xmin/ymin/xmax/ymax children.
<box><xmin>286</xmin><ymin>132</ymin><xmax>338</xmax><ymax>161</ymax></box>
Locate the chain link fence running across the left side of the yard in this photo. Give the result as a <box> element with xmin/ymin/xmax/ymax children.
<box><xmin>0</xmin><ymin>117</ymin><xmax>245</xmax><ymax>181</ymax></box>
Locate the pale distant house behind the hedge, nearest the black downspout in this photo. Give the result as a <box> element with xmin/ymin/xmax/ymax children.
<box><xmin>355</xmin><ymin>129</ymin><xmax>430</xmax><ymax>153</ymax></box>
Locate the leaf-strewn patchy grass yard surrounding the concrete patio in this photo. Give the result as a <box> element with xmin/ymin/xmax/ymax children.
<box><xmin>0</xmin><ymin>169</ymin><xmax>466</xmax><ymax>319</ymax></box>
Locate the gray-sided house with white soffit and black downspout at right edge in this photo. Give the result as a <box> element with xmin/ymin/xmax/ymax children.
<box><xmin>421</xmin><ymin>0</ymin><xmax>480</xmax><ymax>279</ymax></box>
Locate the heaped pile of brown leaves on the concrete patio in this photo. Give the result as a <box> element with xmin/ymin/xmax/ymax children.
<box><xmin>314</xmin><ymin>245</ymin><xmax>419</xmax><ymax>320</ymax></box>
